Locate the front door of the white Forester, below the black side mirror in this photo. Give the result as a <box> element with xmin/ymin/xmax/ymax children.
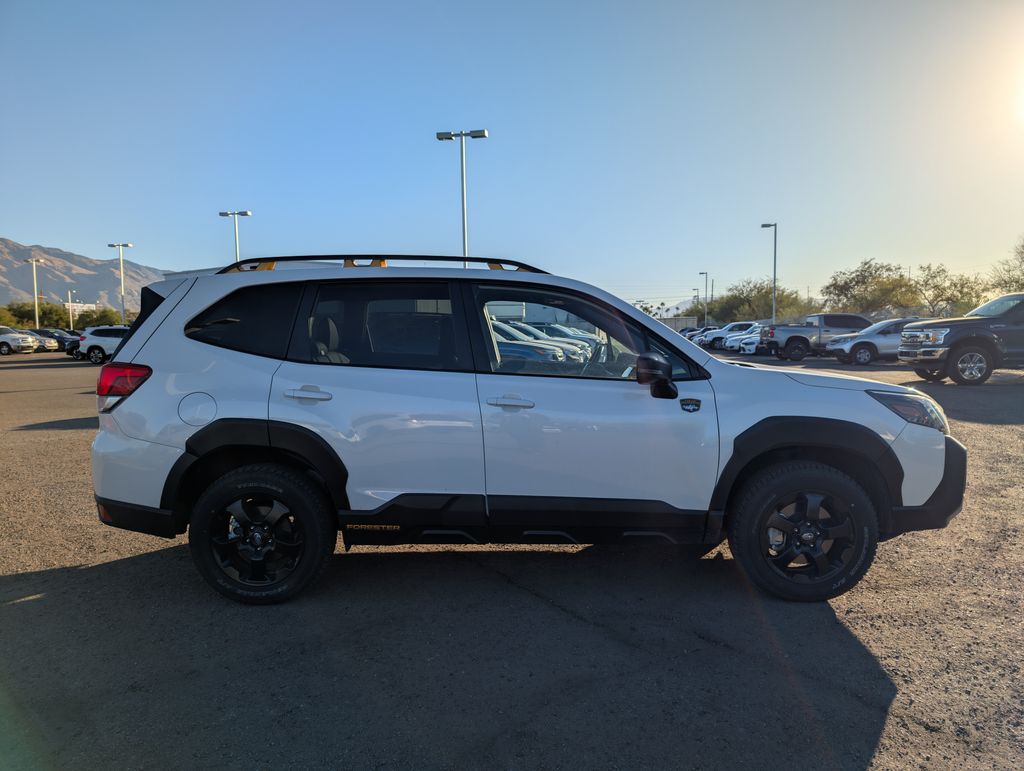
<box><xmin>467</xmin><ymin>284</ymin><xmax>718</xmax><ymax>541</ymax></box>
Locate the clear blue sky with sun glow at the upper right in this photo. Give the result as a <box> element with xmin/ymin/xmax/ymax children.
<box><xmin>0</xmin><ymin>0</ymin><xmax>1024</xmax><ymax>302</ymax></box>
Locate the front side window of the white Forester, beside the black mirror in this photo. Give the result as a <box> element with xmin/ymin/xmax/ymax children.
<box><xmin>473</xmin><ymin>285</ymin><xmax>692</xmax><ymax>380</ymax></box>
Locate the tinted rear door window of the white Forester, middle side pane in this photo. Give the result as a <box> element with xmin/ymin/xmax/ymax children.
<box><xmin>292</xmin><ymin>281</ymin><xmax>472</xmax><ymax>371</ymax></box>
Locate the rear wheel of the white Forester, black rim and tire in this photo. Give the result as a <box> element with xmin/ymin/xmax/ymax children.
<box><xmin>188</xmin><ymin>464</ymin><xmax>338</xmax><ymax>605</ymax></box>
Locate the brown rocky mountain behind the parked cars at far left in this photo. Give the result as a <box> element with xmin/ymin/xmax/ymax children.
<box><xmin>0</xmin><ymin>239</ymin><xmax>163</xmax><ymax>310</ymax></box>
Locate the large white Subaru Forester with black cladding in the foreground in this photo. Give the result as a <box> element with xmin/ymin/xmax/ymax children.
<box><xmin>92</xmin><ymin>257</ymin><xmax>967</xmax><ymax>603</ymax></box>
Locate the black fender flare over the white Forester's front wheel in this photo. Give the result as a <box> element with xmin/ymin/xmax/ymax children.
<box><xmin>710</xmin><ymin>416</ymin><xmax>903</xmax><ymax>516</ymax></box>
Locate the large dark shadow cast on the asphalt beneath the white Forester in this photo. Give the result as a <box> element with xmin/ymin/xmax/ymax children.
<box><xmin>0</xmin><ymin>546</ymin><xmax>895</xmax><ymax>769</ymax></box>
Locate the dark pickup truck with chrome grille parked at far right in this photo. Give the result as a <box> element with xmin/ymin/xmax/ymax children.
<box><xmin>898</xmin><ymin>294</ymin><xmax>1024</xmax><ymax>385</ymax></box>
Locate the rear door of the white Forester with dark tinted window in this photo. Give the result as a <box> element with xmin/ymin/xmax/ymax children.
<box><xmin>269</xmin><ymin>280</ymin><xmax>484</xmax><ymax>518</ymax></box>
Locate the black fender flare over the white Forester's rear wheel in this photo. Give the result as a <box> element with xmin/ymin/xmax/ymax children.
<box><xmin>160</xmin><ymin>418</ymin><xmax>348</xmax><ymax>509</ymax></box>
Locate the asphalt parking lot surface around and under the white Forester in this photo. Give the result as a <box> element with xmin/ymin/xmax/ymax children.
<box><xmin>0</xmin><ymin>354</ymin><xmax>1024</xmax><ymax>769</ymax></box>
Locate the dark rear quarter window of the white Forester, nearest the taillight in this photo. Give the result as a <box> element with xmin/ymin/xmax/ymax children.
<box><xmin>185</xmin><ymin>284</ymin><xmax>302</xmax><ymax>358</ymax></box>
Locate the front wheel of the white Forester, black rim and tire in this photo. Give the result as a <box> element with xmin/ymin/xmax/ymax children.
<box><xmin>728</xmin><ymin>461</ymin><xmax>879</xmax><ymax>602</ymax></box>
